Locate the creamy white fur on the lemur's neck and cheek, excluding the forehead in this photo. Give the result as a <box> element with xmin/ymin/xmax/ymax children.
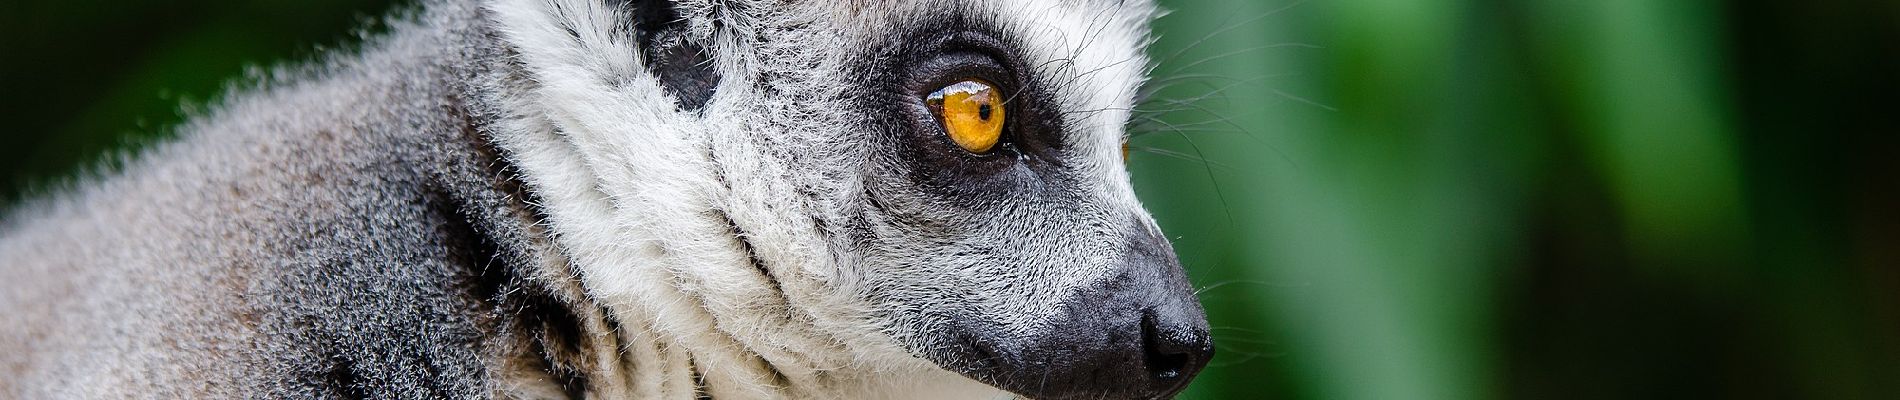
<box><xmin>488</xmin><ymin>0</ymin><xmax>980</xmax><ymax>398</ymax></box>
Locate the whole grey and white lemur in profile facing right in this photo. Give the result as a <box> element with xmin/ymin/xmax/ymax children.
<box><xmin>0</xmin><ymin>0</ymin><xmax>1212</xmax><ymax>400</ymax></box>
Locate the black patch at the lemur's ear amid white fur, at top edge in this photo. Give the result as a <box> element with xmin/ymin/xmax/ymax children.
<box><xmin>614</xmin><ymin>0</ymin><xmax>720</xmax><ymax>112</ymax></box>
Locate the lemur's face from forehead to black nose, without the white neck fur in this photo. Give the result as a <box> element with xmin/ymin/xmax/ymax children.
<box><xmin>775</xmin><ymin>0</ymin><xmax>1212</xmax><ymax>398</ymax></box>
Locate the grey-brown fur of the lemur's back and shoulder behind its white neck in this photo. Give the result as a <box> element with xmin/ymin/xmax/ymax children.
<box><xmin>0</xmin><ymin>4</ymin><xmax>536</xmax><ymax>398</ymax></box>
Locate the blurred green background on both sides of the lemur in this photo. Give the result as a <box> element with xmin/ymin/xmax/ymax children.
<box><xmin>0</xmin><ymin>0</ymin><xmax>1900</xmax><ymax>398</ymax></box>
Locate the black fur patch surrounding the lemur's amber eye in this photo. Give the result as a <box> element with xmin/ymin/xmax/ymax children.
<box><xmin>849</xmin><ymin>23</ymin><xmax>1077</xmax><ymax>214</ymax></box>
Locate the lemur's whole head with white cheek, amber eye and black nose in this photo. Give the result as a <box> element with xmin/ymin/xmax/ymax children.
<box><xmin>488</xmin><ymin>0</ymin><xmax>1212</xmax><ymax>398</ymax></box>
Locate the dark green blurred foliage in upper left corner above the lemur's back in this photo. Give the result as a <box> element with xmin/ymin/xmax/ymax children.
<box><xmin>0</xmin><ymin>0</ymin><xmax>390</xmax><ymax>203</ymax></box>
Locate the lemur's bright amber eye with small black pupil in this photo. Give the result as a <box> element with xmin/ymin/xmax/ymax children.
<box><xmin>923</xmin><ymin>80</ymin><xmax>1003</xmax><ymax>154</ymax></box>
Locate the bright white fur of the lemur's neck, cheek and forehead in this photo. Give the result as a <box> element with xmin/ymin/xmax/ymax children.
<box><xmin>486</xmin><ymin>0</ymin><xmax>1153</xmax><ymax>398</ymax></box>
